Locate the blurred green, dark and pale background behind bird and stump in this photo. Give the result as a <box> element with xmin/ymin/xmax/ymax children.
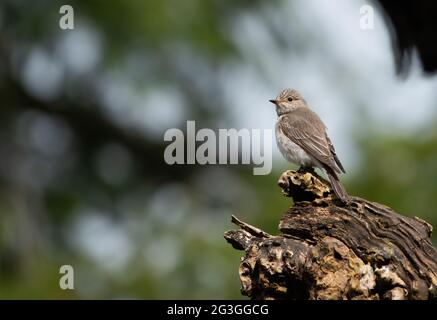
<box><xmin>0</xmin><ymin>0</ymin><xmax>437</xmax><ymax>299</ymax></box>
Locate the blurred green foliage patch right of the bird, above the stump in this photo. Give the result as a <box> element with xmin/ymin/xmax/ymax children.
<box><xmin>350</xmin><ymin>125</ymin><xmax>437</xmax><ymax>226</ymax></box>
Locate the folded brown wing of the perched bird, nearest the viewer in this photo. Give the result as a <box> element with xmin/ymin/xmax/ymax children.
<box><xmin>279</xmin><ymin>114</ymin><xmax>341</xmax><ymax>173</ymax></box>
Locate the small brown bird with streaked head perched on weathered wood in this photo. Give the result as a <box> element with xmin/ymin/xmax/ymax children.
<box><xmin>269</xmin><ymin>89</ymin><xmax>349</xmax><ymax>202</ymax></box>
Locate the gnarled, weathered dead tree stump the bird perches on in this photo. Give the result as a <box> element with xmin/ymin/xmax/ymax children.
<box><xmin>225</xmin><ymin>171</ymin><xmax>437</xmax><ymax>300</ymax></box>
